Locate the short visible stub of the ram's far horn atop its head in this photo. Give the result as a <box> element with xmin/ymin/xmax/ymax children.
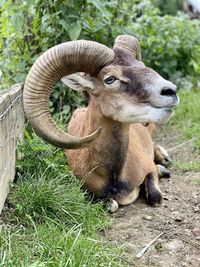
<box><xmin>113</xmin><ymin>35</ymin><xmax>141</xmax><ymax>60</ymax></box>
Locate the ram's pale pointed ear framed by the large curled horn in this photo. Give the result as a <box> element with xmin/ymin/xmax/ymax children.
<box><xmin>61</xmin><ymin>72</ymin><xmax>94</xmax><ymax>91</ymax></box>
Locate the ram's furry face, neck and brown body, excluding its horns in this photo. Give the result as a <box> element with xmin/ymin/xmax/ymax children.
<box><xmin>65</xmin><ymin>49</ymin><xmax>178</xmax><ymax>205</ymax></box>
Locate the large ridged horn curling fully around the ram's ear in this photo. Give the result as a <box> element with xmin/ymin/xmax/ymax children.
<box><xmin>23</xmin><ymin>40</ymin><xmax>114</xmax><ymax>149</ymax></box>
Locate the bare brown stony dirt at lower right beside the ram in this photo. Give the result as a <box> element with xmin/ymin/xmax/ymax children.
<box><xmin>103</xmin><ymin>134</ymin><xmax>200</xmax><ymax>267</ymax></box>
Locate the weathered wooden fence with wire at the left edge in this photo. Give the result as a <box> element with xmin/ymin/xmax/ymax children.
<box><xmin>0</xmin><ymin>84</ymin><xmax>24</xmax><ymax>213</ymax></box>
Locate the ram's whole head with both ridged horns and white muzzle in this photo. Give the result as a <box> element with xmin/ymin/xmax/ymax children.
<box><xmin>24</xmin><ymin>35</ymin><xmax>179</xmax><ymax>148</ymax></box>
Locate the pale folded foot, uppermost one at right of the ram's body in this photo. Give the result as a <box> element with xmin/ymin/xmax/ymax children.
<box><xmin>154</xmin><ymin>144</ymin><xmax>171</xmax><ymax>166</ymax></box>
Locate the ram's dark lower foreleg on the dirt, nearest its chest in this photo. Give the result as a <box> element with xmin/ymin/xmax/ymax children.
<box><xmin>145</xmin><ymin>173</ymin><xmax>162</xmax><ymax>206</ymax></box>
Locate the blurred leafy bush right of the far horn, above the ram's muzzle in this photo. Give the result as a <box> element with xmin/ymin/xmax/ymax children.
<box><xmin>130</xmin><ymin>14</ymin><xmax>200</xmax><ymax>89</ymax></box>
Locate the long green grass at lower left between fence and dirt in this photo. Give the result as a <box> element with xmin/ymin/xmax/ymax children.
<box><xmin>0</xmin><ymin>132</ymin><xmax>127</xmax><ymax>267</ymax></box>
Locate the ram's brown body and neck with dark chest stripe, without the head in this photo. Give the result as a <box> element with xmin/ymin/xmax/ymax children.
<box><xmin>65</xmin><ymin>97</ymin><xmax>162</xmax><ymax>205</ymax></box>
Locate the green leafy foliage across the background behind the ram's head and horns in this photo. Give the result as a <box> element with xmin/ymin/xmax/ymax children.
<box><xmin>0</xmin><ymin>0</ymin><xmax>200</xmax><ymax>117</ymax></box>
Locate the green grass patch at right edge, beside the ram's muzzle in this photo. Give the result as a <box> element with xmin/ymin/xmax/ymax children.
<box><xmin>170</xmin><ymin>89</ymin><xmax>200</xmax><ymax>152</ymax></box>
